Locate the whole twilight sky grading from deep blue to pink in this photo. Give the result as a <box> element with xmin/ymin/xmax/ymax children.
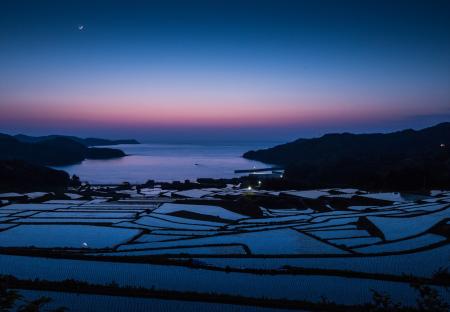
<box><xmin>0</xmin><ymin>0</ymin><xmax>450</xmax><ymax>141</ymax></box>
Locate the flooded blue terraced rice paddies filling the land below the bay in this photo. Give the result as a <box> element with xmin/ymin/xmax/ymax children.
<box><xmin>0</xmin><ymin>188</ymin><xmax>450</xmax><ymax>311</ymax></box>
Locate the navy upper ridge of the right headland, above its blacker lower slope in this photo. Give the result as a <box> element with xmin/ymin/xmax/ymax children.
<box><xmin>243</xmin><ymin>123</ymin><xmax>450</xmax><ymax>165</ymax></box>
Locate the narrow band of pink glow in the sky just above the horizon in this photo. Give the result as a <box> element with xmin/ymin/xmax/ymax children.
<box><xmin>0</xmin><ymin>96</ymin><xmax>444</xmax><ymax>128</ymax></box>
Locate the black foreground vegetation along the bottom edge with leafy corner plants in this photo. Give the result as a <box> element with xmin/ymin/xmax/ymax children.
<box><xmin>0</xmin><ymin>276</ymin><xmax>449</xmax><ymax>312</ymax></box>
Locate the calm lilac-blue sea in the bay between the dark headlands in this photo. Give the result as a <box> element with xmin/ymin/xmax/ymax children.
<box><xmin>54</xmin><ymin>142</ymin><xmax>278</xmax><ymax>184</ymax></box>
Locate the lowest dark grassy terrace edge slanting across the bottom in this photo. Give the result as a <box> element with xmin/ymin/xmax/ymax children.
<box><xmin>0</xmin><ymin>275</ymin><xmax>448</xmax><ymax>312</ymax></box>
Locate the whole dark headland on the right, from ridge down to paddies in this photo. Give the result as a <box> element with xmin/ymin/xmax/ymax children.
<box><xmin>244</xmin><ymin>123</ymin><xmax>450</xmax><ymax>190</ymax></box>
